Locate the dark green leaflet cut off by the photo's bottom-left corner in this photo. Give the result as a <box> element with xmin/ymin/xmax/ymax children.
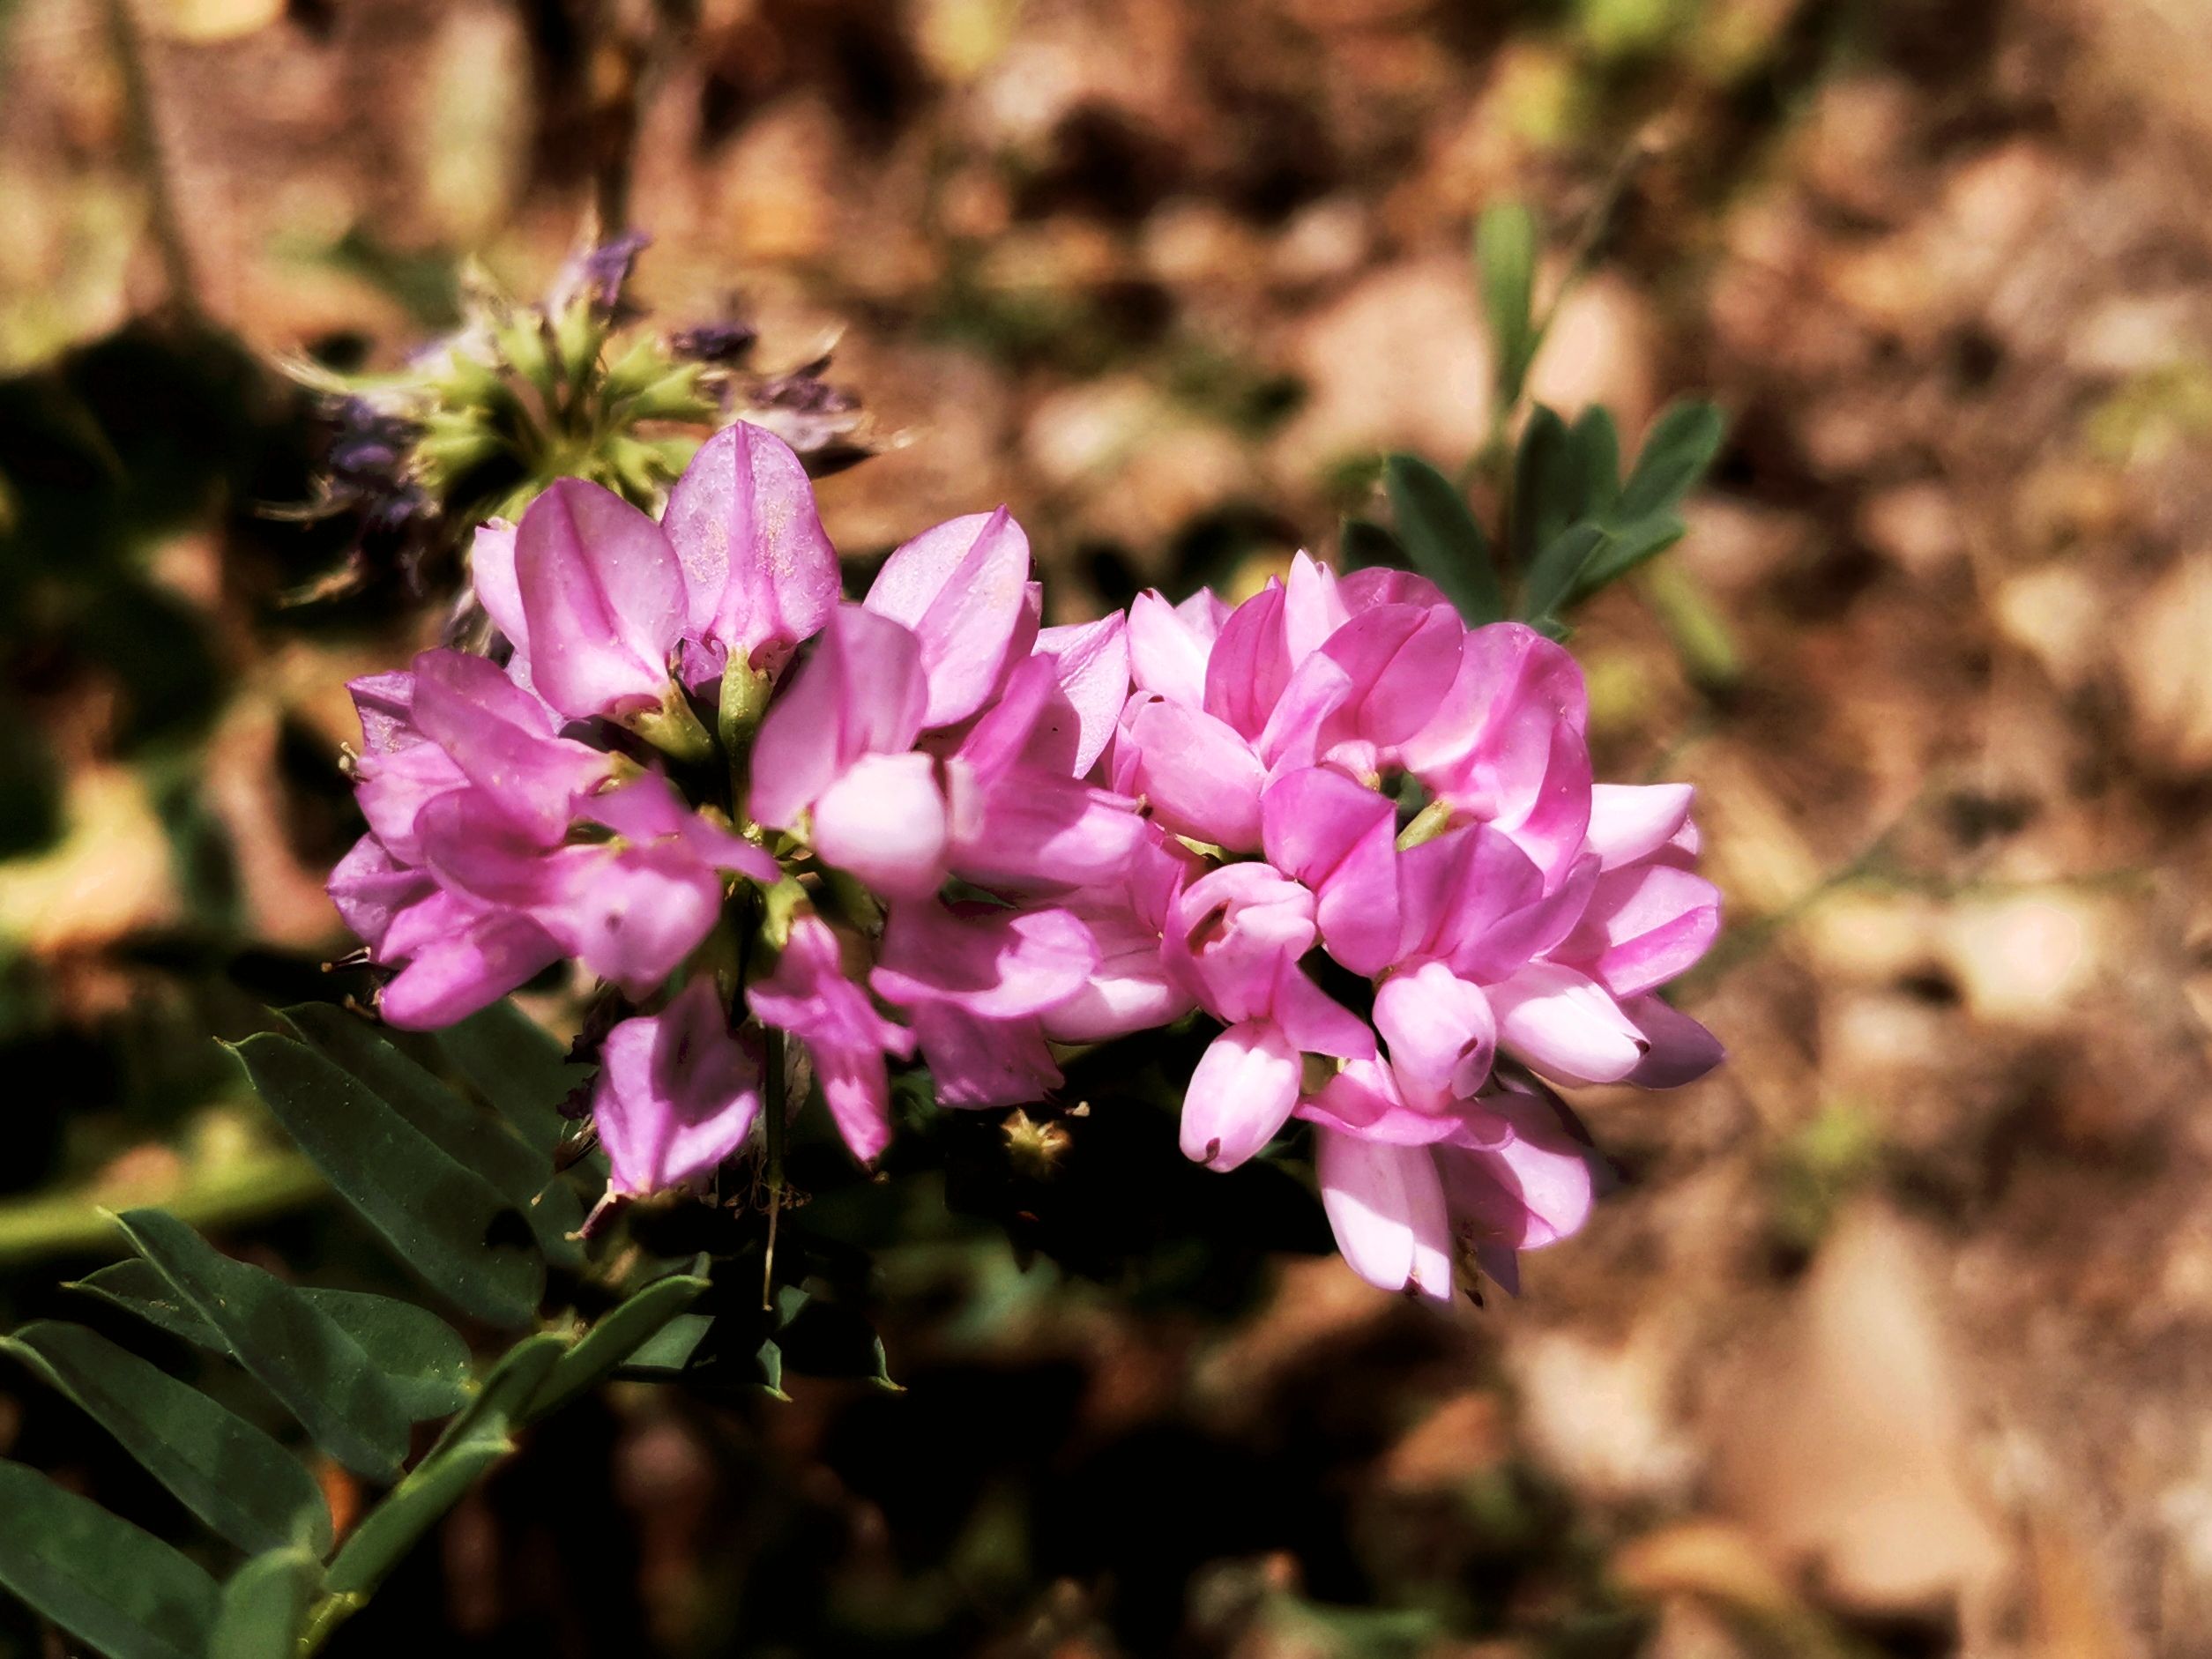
<box><xmin>0</xmin><ymin>1460</ymin><xmax>217</xmax><ymax>1659</ymax></box>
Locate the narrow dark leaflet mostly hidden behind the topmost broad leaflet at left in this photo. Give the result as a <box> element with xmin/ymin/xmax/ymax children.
<box><xmin>283</xmin><ymin>1002</ymin><xmax>584</xmax><ymax>1268</ymax></box>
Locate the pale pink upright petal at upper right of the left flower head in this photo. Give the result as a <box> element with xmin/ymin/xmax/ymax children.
<box><xmin>868</xmin><ymin>507</ymin><xmax>1029</xmax><ymax>730</ymax></box>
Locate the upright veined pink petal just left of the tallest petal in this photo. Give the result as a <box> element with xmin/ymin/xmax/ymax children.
<box><xmin>516</xmin><ymin>478</ymin><xmax>683</xmax><ymax>719</ymax></box>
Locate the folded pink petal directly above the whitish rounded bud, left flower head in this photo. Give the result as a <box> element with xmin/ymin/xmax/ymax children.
<box><xmin>750</xmin><ymin>604</ymin><xmax>929</xmax><ymax>830</ymax></box>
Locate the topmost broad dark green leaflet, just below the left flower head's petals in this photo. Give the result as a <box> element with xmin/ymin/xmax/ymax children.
<box><xmin>236</xmin><ymin>1033</ymin><xmax>547</xmax><ymax>1325</ymax></box>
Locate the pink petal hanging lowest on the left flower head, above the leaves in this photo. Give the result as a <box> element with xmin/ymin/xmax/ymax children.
<box><xmin>591</xmin><ymin>976</ymin><xmax>761</xmax><ymax>1193</ymax></box>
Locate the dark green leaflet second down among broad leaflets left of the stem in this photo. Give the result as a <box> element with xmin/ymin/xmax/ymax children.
<box><xmin>117</xmin><ymin>1210</ymin><xmax>407</xmax><ymax>1480</ymax></box>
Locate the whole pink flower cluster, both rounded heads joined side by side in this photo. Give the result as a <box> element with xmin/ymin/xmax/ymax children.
<box><xmin>331</xmin><ymin>422</ymin><xmax>1718</xmax><ymax>1296</ymax></box>
